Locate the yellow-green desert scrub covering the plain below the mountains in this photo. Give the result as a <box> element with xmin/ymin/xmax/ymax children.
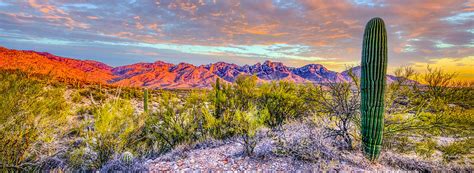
<box><xmin>0</xmin><ymin>68</ymin><xmax>474</xmax><ymax>171</ymax></box>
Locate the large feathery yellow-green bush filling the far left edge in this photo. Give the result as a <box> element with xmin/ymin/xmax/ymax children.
<box><xmin>0</xmin><ymin>72</ymin><xmax>68</xmax><ymax>169</ymax></box>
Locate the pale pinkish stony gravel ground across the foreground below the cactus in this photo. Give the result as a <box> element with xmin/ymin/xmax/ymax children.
<box><xmin>145</xmin><ymin>122</ymin><xmax>474</xmax><ymax>172</ymax></box>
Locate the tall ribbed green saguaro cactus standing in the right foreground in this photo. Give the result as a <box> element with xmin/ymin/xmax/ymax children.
<box><xmin>360</xmin><ymin>18</ymin><xmax>387</xmax><ymax>161</ymax></box>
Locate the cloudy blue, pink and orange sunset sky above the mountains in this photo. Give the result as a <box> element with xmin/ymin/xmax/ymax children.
<box><xmin>0</xmin><ymin>0</ymin><xmax>474</xmax><ymax>81</ymax></box>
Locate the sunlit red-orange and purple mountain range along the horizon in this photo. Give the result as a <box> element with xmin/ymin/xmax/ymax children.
<box><xmin>0</xmin><ymin>47</ymin><xmax>402</xmax><ymax>88</ymax></box>
